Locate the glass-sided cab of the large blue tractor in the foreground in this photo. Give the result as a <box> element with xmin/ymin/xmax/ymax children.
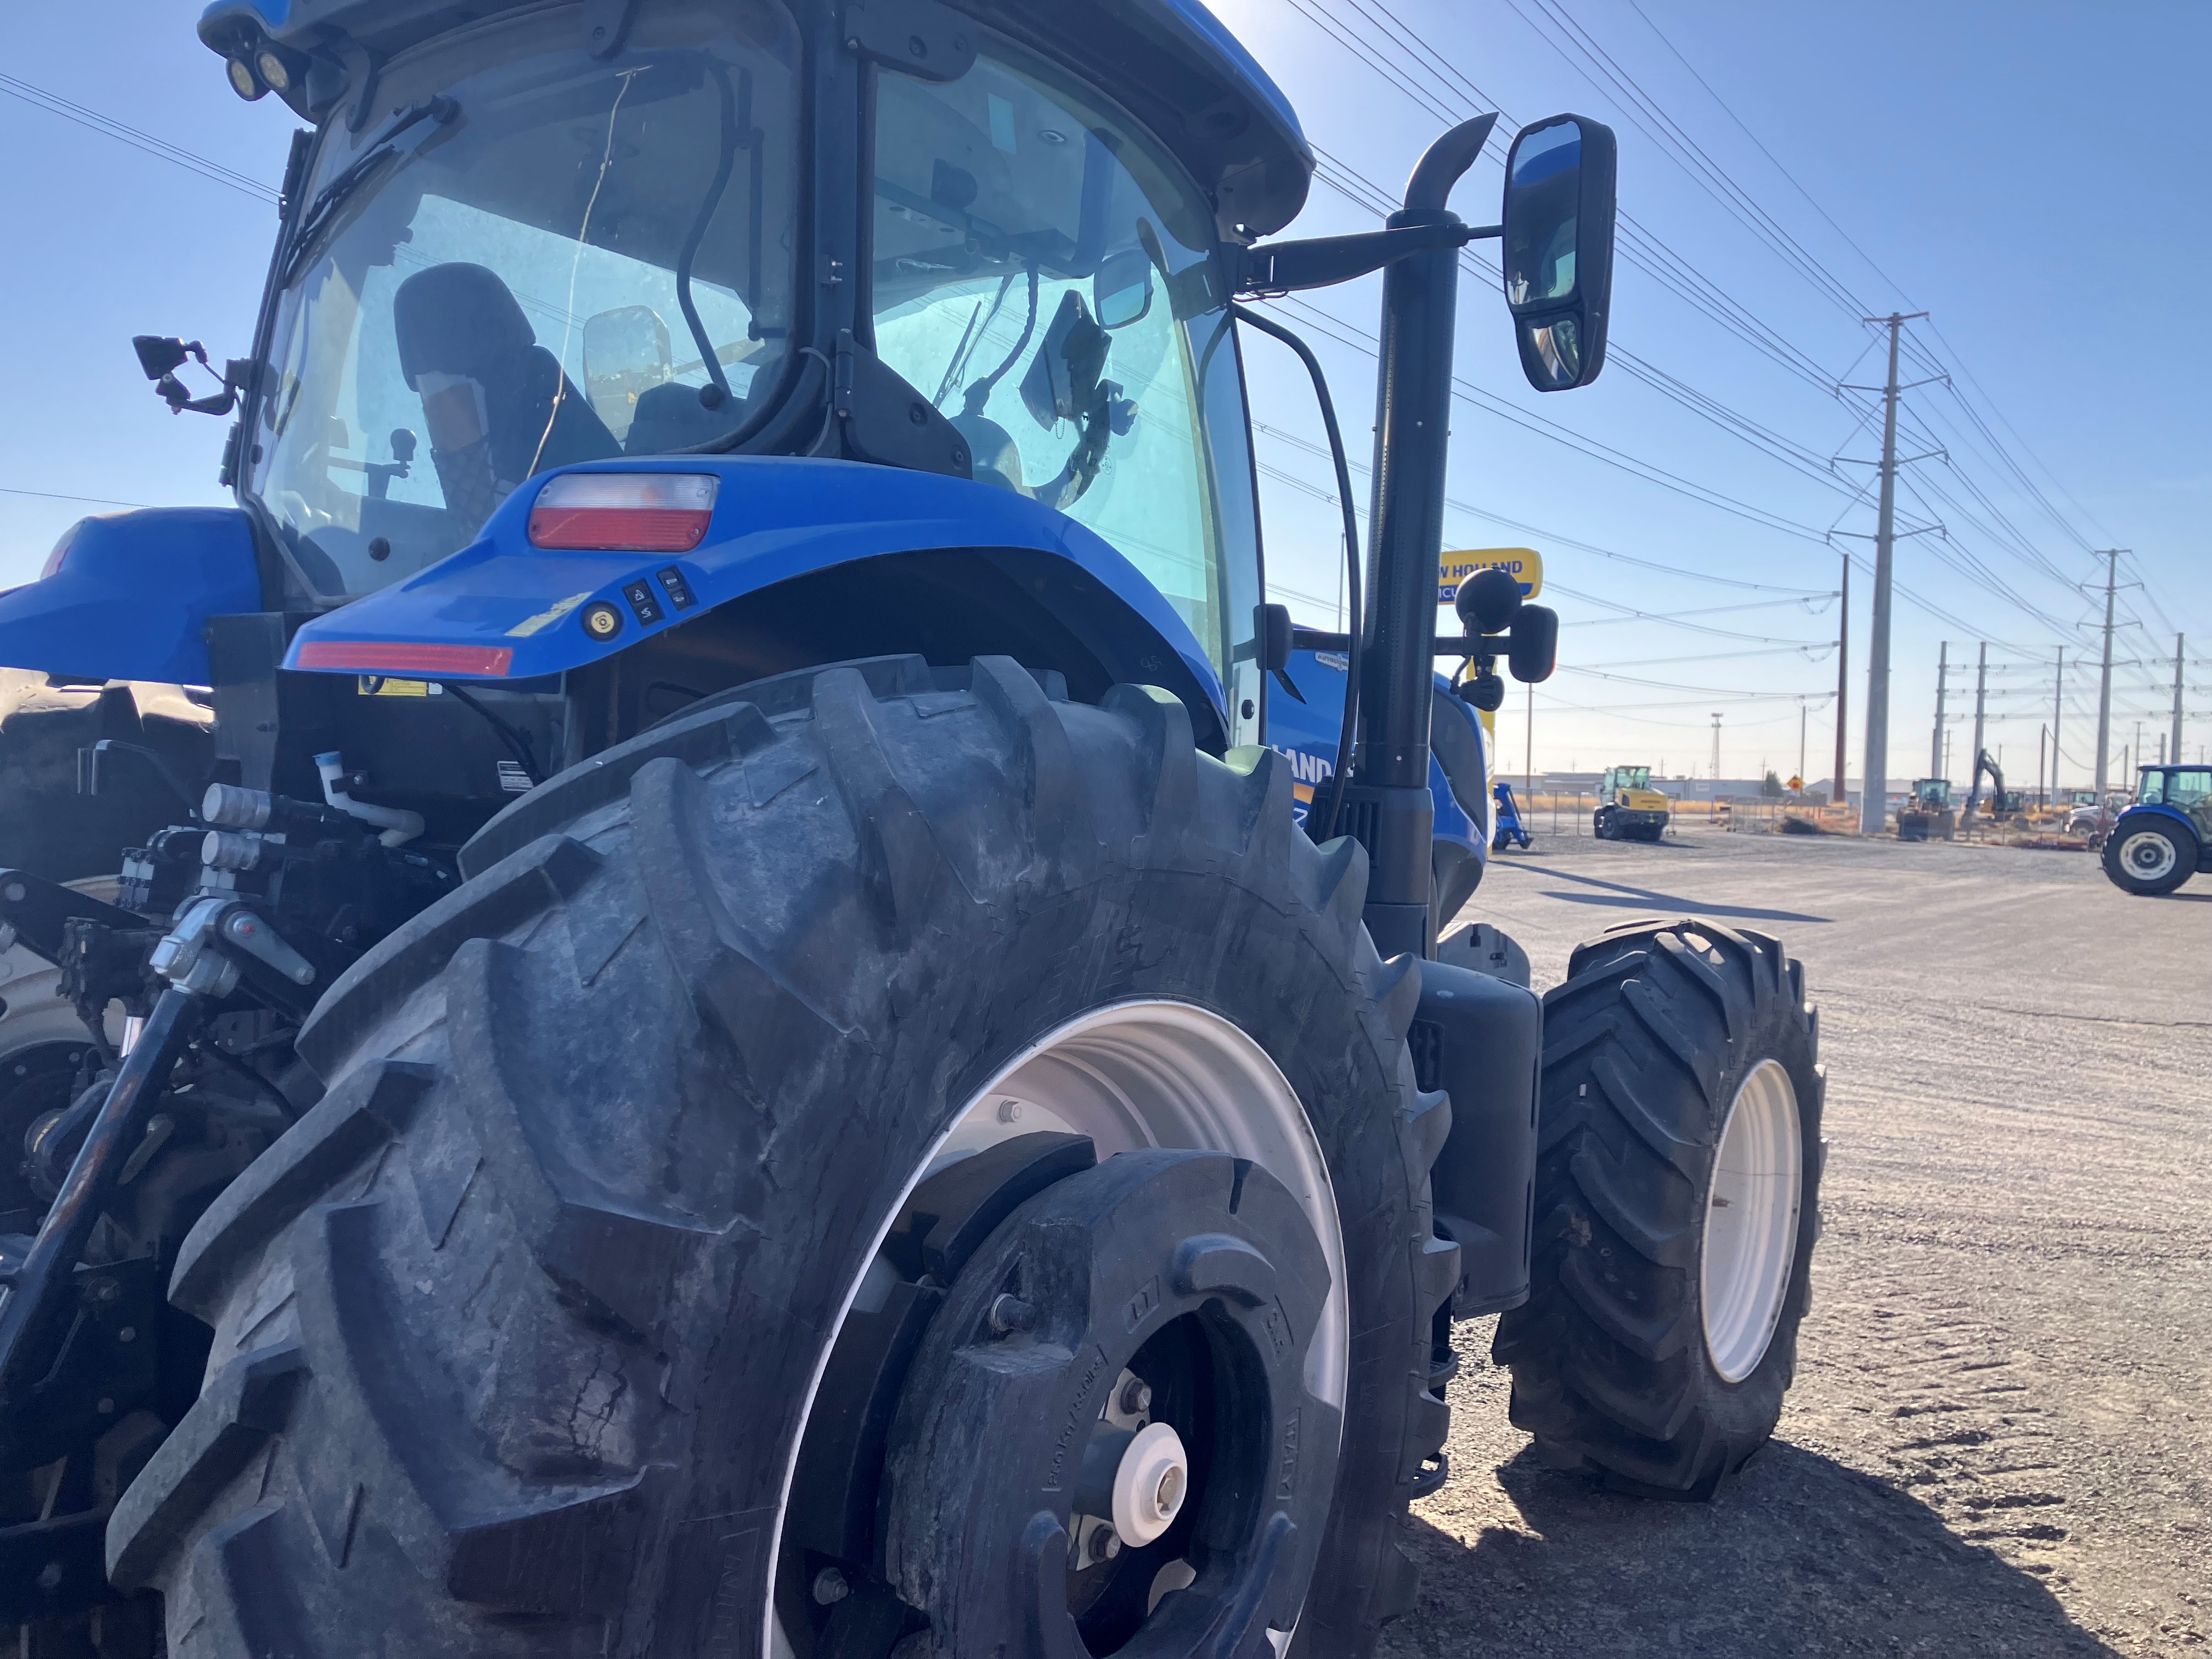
<box><xmin>183</xmin><ymin>0</ymin><xmax>1310</xmax><ymax>748</ymax></box>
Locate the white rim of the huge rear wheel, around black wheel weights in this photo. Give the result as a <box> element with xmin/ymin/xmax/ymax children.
<box><xmin>765</xmin><ymin>1000</ymin><xmax>1352</xmax><ymax>1657</ymax></box>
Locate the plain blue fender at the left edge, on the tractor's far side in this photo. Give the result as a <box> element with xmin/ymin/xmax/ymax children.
<box><xmin>0</xmin><ymin>506</ymin><xmax>261</xmax><ymax>686</ymax></box>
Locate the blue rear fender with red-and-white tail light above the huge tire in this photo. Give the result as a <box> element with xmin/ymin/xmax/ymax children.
<box><xmin>285</xmin><ymin>456</ymin><xmax>1228</xmax><ymax>721</ymax></box>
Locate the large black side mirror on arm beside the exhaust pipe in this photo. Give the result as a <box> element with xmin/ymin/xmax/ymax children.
<box><xmin>1500</xmin><ymin>115</ymin><xmax>1617</xmax><ymax>392</ymax></box>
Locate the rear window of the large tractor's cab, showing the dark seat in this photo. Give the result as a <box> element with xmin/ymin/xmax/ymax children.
<box><xmin>246</xmin><ymin>0</ymin><xmax>799</xmax><ymax>600</ymax></box>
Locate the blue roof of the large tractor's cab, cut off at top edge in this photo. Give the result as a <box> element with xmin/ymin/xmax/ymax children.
<box><xmin>199</xmin><ymin>0</ymin><xmax>1314</xmax><ymax>239</ymax></box>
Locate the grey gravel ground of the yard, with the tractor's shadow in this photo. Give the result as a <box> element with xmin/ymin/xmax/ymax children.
<box><xmin>1385</xmin><ymin>830</ymin><xmax>2212</xmax><ymax>1659</ymax></box>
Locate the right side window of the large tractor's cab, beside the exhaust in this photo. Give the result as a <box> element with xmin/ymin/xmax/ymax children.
<box><xmin>872</xmin><ymin>36</ymin><xmax>1261</xmax><ymax>703</ymax></box>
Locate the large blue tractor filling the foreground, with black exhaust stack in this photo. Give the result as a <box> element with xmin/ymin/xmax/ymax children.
<box><xmin>0</xmin><ymin>0</ymin><xmax>1820</xmax><ymax>1659</ymax></box>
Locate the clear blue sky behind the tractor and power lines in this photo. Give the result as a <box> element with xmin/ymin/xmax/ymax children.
<box><xmin>0</xmin><ymin>0</ymin><xmax>2212</xmax><ymax>783</ymax></box>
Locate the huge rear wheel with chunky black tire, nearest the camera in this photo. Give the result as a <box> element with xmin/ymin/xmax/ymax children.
<box><xmin>109</xmin><ymin>659</ymin><xmax>1458</xmax><ymax>1659</ymax></box>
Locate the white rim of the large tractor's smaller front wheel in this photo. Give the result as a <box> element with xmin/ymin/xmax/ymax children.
<box><xmin>1699</xmin><ymin>1059</ymin><xmax>1805</xmax><ymax>1383</ymax></box>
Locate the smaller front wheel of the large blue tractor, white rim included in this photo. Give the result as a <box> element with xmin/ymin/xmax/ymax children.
<box><xmin>1493</xmin><ymin>920</ymin><xmax>1822</xmax><ymax>1498</ymax></box>
